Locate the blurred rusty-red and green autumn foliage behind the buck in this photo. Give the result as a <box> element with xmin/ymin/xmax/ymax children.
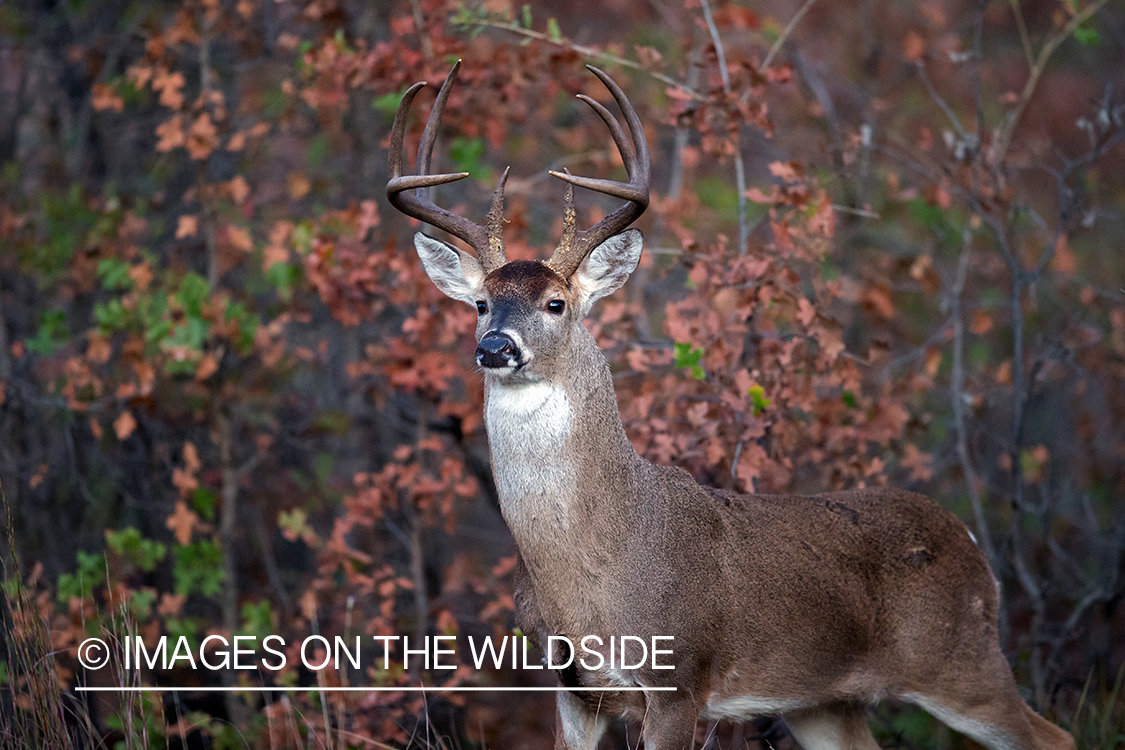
<box><xmin>0</xmin><ymin>0</ymin><xmax>1125</xmax><ymax>748</ymax></box>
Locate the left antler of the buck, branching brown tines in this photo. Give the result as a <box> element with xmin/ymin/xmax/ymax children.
<box><xmin>387</xmin><ymin>60</ymin><xmax>510</xmax><ymax>273</ymax></box>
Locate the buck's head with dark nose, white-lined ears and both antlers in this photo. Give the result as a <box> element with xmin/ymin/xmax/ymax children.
<box><xmin>387</xmin><ymin>61</ymin><xmax>650</xmax><ymax>382</ymax></box>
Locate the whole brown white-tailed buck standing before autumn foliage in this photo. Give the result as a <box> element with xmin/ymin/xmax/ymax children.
<box><xmin>387</xmin><ymin>61</ymin><xmax>1074</xmax><ymax>750</ymax></box>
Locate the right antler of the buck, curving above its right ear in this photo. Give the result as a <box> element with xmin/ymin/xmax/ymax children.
<box><xmin>547</xmin><ymin>65</ymin><xmax>651</xmax><ymax>279</ymax></box>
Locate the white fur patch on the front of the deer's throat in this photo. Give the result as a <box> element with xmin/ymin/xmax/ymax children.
<box><xmin>485</xmin><ymin>382</ymin><xmax>575</xmax><ymax>535</ymax></box>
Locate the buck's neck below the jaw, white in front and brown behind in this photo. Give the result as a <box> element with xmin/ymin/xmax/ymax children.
<box><xmin>485</xmin><ymin>326</ymin><xmax>639</xmax><ymax>555</ymax></box>
